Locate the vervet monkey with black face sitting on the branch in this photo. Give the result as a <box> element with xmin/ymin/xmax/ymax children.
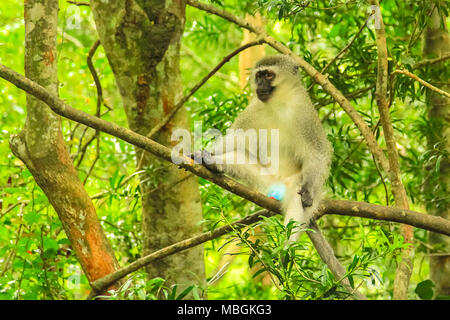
<box><xmin>196</xmin><ymin>55</ymin><xmax>332</xmax><ymax>241</ymax></box>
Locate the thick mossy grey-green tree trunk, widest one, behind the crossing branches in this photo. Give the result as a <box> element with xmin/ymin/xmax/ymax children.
<box><xmin>91</xmin><ymin>0</ymin><xmax>205</xmax><ymax>286</ymax></box>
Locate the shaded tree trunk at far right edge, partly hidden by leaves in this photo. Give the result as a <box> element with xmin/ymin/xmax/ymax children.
<box><xmin>423</xmin><ymin>4</ymin><xmax>450</xmax><ymax>296</ymax></box>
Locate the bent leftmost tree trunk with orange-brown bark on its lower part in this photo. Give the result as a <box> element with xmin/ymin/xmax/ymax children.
<box><xmin>10</xmin><ymin>0</ymin><xmax>119</xmax><ymax>290</ymax></box>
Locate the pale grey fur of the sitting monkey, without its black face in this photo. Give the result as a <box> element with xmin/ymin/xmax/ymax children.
<box><xmin>210</xmin><ymin>55</ymin><xmax>332</xmax><ymax>240</ymax></box>
